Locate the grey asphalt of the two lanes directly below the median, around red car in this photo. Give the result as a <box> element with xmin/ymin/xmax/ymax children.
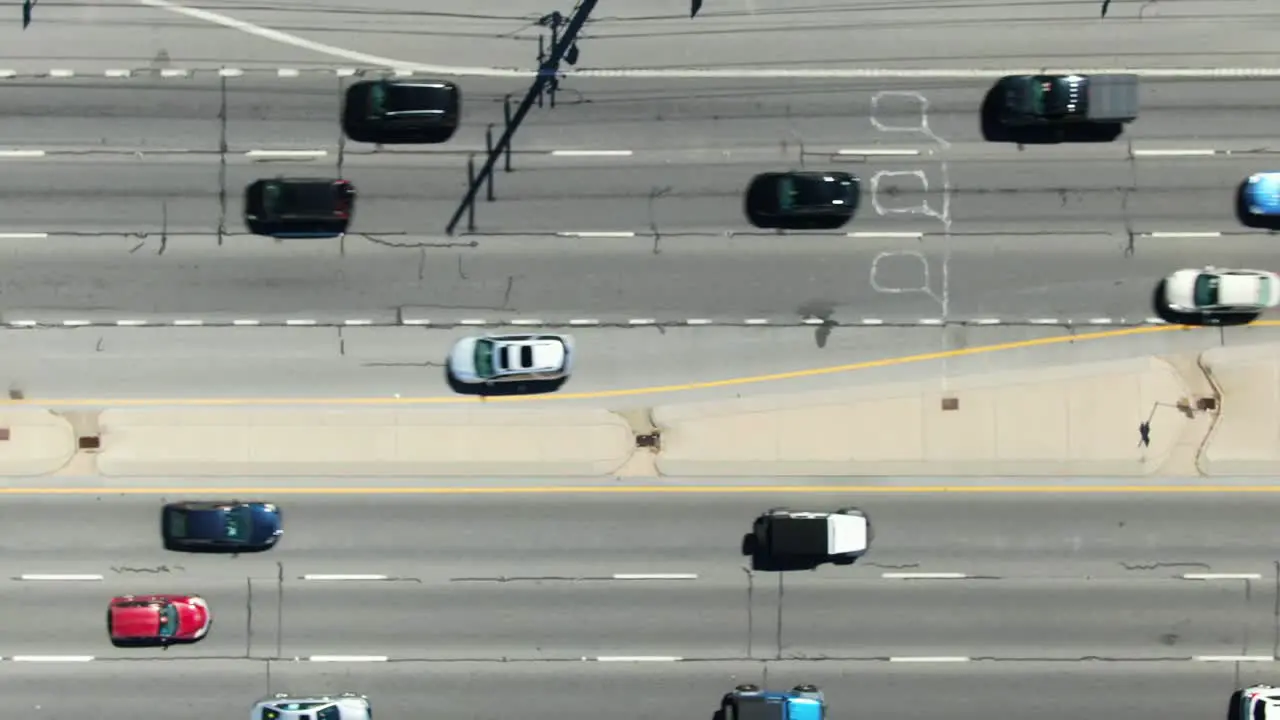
<box><xmin>0</xmin><ymin>496</ymin><xmax>1277</xmax><ymax>661</ymax></box>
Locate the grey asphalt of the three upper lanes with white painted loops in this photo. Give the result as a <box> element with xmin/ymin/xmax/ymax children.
<box><xmin>0</xmin><ymin>78</ymin><xmax>1276</xmax><ymax>320</ymax></box>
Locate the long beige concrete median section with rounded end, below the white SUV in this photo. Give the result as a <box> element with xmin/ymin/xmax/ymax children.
<box><xmin>96</xmin><ymin>406</ymin><xmax>635</xmax><ymax>477</ymax></box>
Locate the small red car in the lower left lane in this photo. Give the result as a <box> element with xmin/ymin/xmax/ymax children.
<box><xmin>106</xmin><ymin>594</ymin><xmax>214</xmax><ymax>646</ymax></box>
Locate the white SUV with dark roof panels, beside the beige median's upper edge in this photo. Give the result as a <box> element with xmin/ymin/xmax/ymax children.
<box><xmin>448</xmin><ymin>334</ymin><xmax>573</xmax><ymax>384</ymax></box>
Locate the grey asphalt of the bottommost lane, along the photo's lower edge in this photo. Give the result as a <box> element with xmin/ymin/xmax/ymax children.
<box><xmin>0</xmin><ymin>661</ymin><xmax>1274</xmax><ymax>720</ymax></box>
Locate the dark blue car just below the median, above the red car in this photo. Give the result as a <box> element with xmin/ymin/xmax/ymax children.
<box><xmin>160</xmin><ymin>500</ymin><xmax>284</xmax><ymax>553</ymax></box>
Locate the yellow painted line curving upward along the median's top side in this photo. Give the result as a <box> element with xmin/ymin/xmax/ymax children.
<box><xmin>0</xmin><ymin>320</ymin><xmax>1254</xmax><ymax>407</ymax></box>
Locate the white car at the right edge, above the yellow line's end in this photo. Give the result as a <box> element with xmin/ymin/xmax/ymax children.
<box><xmin>1164</xmin><ymin>266</ymin><xmax>1280</xmax><ymax>314</ymax></box>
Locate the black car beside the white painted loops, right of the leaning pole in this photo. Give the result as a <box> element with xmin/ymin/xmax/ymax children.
<box><xmin>746</xmin><ymin>172</ymin><xmax>860</xmax><ymax>229</ymax></box>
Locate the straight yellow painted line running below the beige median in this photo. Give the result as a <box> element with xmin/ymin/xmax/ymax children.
<box><xmin>0</xmin><ymin>483</ymin><xmax>1280</xmax><ymax>497</ymax></box>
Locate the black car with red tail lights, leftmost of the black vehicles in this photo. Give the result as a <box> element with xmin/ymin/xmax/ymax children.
<box><xmin>244</xmin><ymin>178</ymin><xmax>356</xmax><ymax>238</ymax></box>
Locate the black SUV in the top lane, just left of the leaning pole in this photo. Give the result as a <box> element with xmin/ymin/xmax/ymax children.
<box><xmin>342</xmin><ymin>79</ymin><xmax>462</xmax><ymax>145</ymax></box>
